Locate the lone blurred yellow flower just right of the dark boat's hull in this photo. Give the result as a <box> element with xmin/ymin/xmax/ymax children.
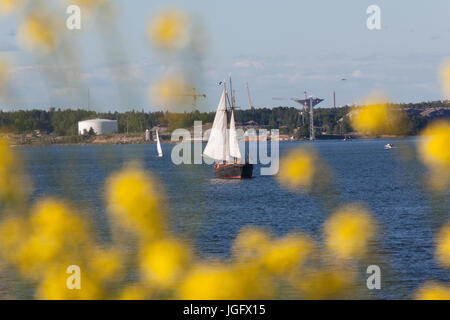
<box><xmin>278</xmin><ymin>149</ymin><xmax>318</xmax><ymax>191</ymax></box>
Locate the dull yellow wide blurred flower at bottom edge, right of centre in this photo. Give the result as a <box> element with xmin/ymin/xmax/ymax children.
<box><xmin>298</xmin><ymin>270</ymin><xmax>355</xmax><ymax>300</ymax></box>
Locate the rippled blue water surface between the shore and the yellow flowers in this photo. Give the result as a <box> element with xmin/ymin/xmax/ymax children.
<box><xmin>17</xmin><ymin>138</ymin><xmax>450</xmax><ymax>299</ymax></box>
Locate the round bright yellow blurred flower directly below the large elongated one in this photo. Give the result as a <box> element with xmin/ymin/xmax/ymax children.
<box><xmin>140</xmin><ymin>239</ymin><xmax>192</xmax><ymax>287</ymax></box>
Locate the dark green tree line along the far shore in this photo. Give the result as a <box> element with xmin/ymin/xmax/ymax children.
<box><xmin>0</xmin><ymin>101</ymin><xmax>449</xmax><ymax>137</ymax></box>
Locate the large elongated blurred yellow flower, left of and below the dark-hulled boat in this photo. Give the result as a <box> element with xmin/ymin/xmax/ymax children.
<box><xmin>106</xmin><ymin>164</ymin><xmax>165</xmax><ymax>238</ymax></box>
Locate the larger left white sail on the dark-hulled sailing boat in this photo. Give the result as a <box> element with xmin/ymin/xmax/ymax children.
<box><xmin>203</xmin><ymin>88</ymin><xmax>230</xmax><ymax>161</ymax></box>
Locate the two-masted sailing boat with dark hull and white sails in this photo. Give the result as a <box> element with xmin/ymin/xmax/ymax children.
<box><xmin>203</xmin><ymin>78</ymin><xmax>253</xmax><ymax>179</ymax></box>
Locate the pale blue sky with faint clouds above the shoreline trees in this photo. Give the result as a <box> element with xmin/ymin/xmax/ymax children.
<box><xmin>0</xmin><ymin>0</ymin><xmax>450</xmax><ymax>111</ymax></box>
